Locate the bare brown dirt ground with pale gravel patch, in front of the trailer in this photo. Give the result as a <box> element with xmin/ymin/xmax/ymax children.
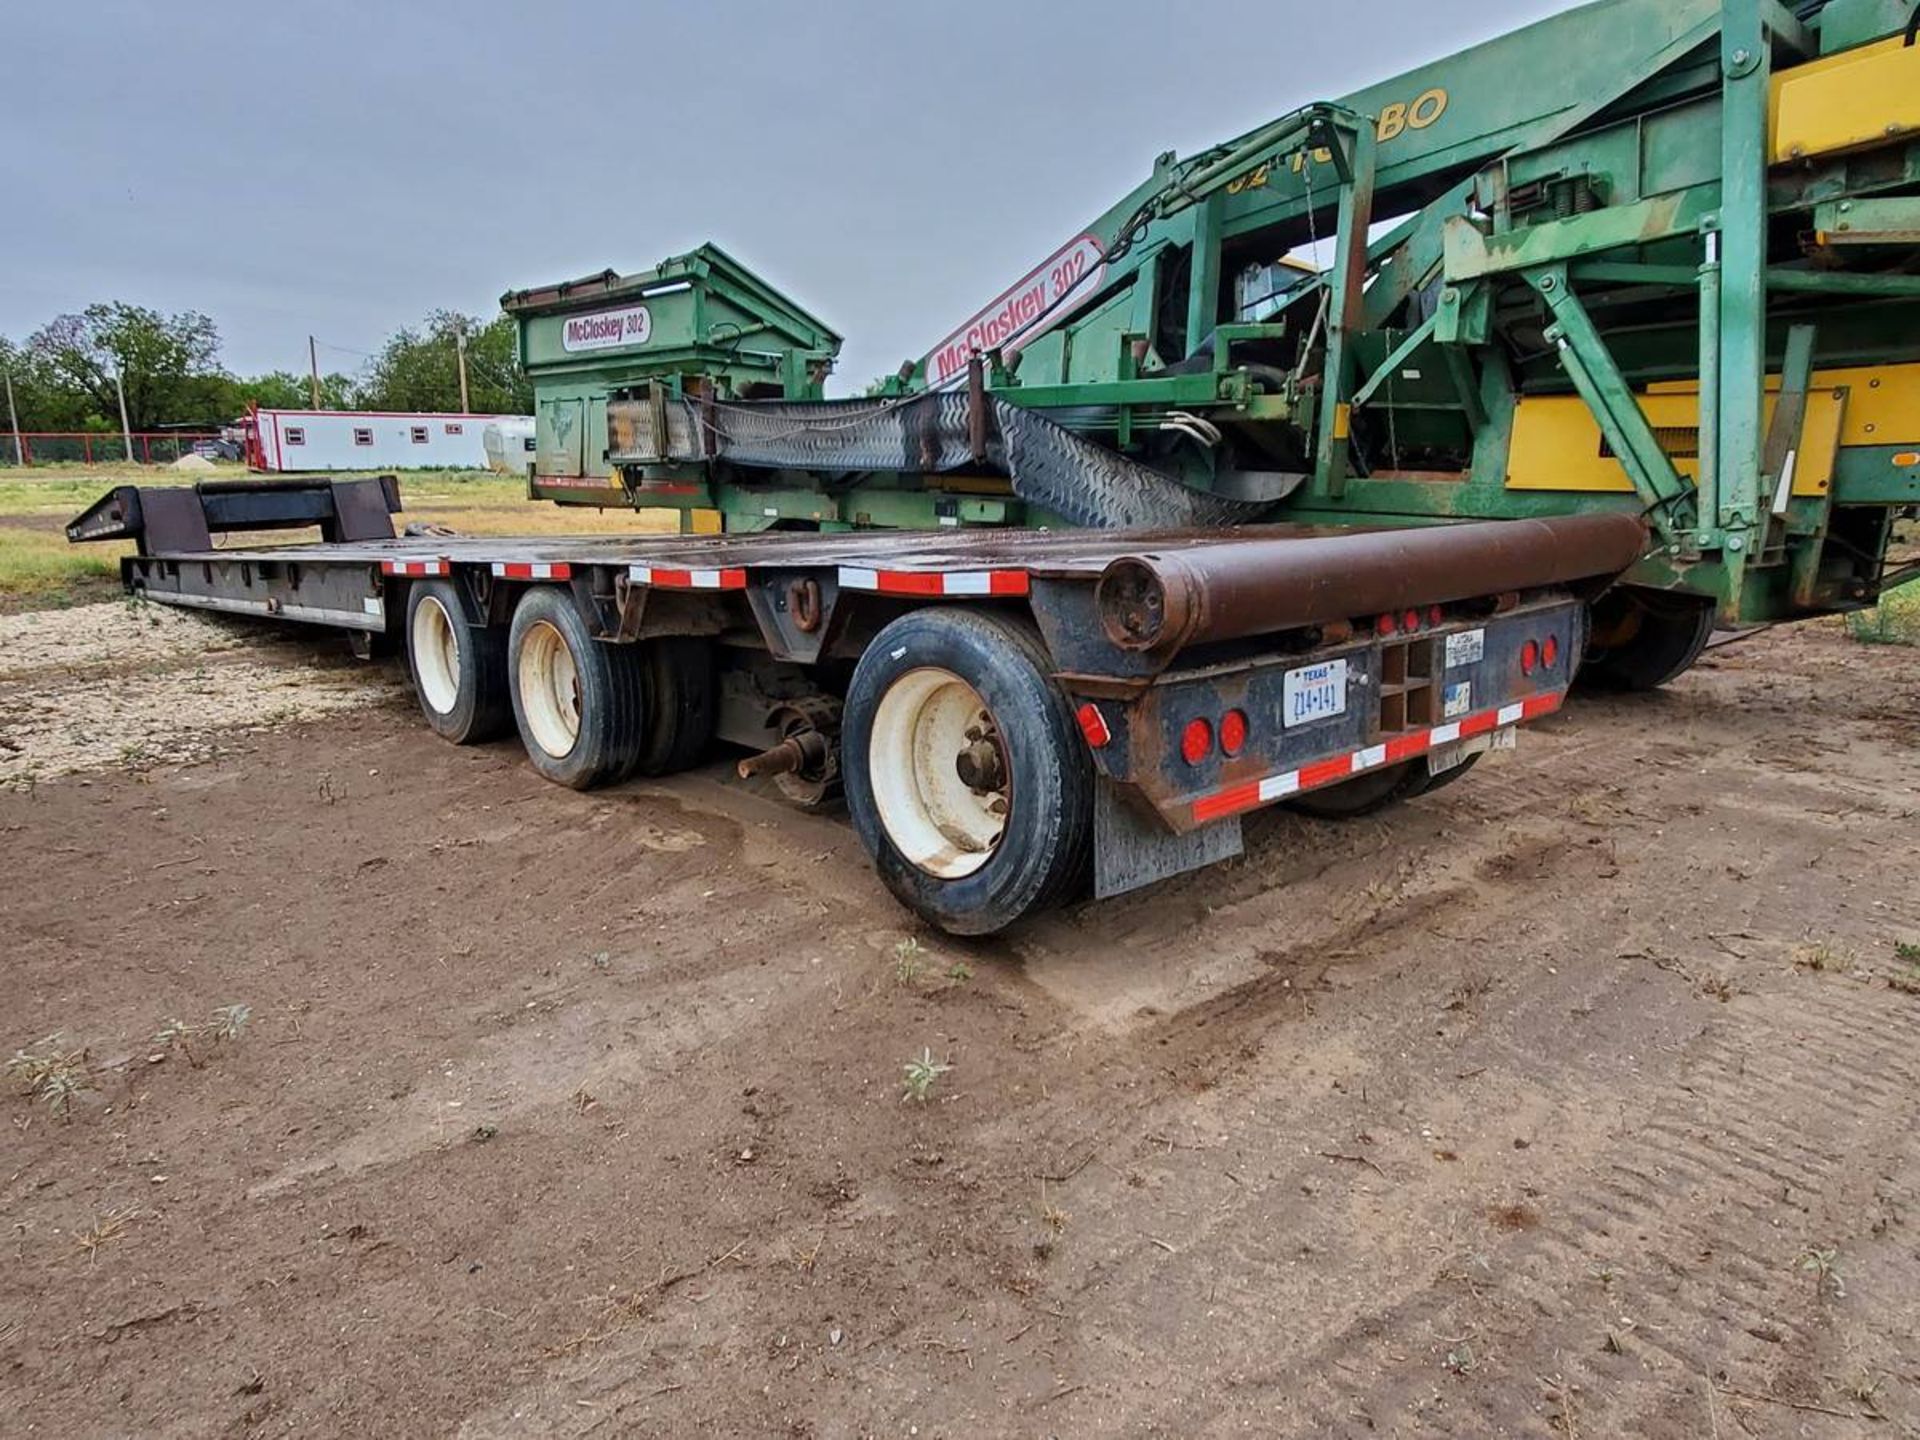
<box><xmin>0</xmin><ymin>605</ymin><xmax>1920</xmax><ymax>1440</ymax></box>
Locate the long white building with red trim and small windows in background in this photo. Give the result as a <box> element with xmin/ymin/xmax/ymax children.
<box><xmin>248</xmin><ymin>409</ymin><xmax>534</xmax><ymax>474</ymax></box>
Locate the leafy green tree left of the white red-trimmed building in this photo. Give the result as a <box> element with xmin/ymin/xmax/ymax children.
<box><xmin>27</xmin><ymin>301</ymin><xmax>227</xmax><ymax>430</ymax></box>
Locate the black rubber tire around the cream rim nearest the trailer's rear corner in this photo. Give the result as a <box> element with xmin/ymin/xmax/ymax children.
<box><xmin>841</xmin><ymin>609</ymin><xmax>1094</xmax><ymax>935</ymax></box>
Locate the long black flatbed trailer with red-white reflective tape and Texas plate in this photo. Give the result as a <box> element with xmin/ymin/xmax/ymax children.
<box><xmin>67</xmin><ymin>478</ymin><xmax>1645</xmax><ymax>933</ymax></box>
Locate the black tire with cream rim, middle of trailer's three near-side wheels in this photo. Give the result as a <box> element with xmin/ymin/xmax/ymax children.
<box><xmin>507</xmin><ymin>586</ymin><xmax>647</xmax><ymax>789</ymax></box>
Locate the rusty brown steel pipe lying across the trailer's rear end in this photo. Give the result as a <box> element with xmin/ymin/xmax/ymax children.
<box><xmin>1094</xmin><ymin>515</ymin><xmax>1647</xmax><ymax>653</ymax></box>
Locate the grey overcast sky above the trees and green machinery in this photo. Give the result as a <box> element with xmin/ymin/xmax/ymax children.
<box><xmin>0</xmin><ymin>0</ymin><xmax>1567</xmax><ymax>392</ymax></box>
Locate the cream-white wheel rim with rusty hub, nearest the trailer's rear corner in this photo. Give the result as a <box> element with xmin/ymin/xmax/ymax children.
<box><xmin>866</xmin><ymin>668</ymin><xmax>1012</xmax><ymax>879</ymax></box>
